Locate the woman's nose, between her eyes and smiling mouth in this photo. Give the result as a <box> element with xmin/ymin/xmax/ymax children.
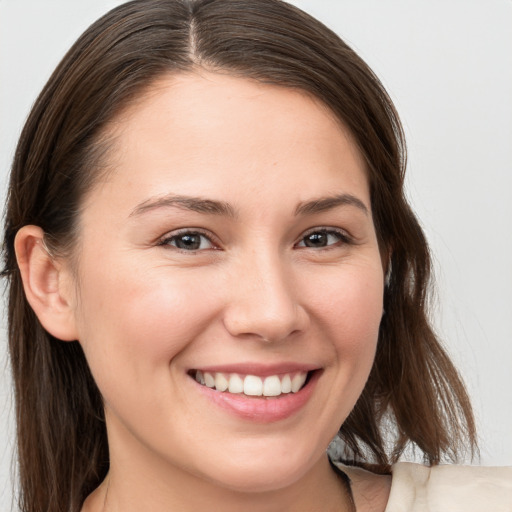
<box><xmin>224</xmin><ymin>255</ymin><xmax>309</xmax><ymax>342</ymax></box>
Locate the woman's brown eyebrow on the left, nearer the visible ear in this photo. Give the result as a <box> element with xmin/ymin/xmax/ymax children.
<box><xmin>129</xmin><ymin>194</ymin><xmax>236</xmax><ymax>218</ymax></box>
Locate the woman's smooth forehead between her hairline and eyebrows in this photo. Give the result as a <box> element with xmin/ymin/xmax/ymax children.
<box><xmin>88</xmin><ymin>72</ymin><xmax>370</xmax><ymax>215</ymax></box>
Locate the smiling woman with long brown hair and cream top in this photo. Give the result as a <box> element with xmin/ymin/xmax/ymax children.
<box><xmin>4</xmin><ymin>0</ymin><xmax>510</xmax><ymax>512</ymax></box>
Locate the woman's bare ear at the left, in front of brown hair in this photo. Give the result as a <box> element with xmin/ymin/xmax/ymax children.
<box><xmin>14</xmin><ymin>226</ymin><xmax>78</xmax><ymax>341</ymax></box>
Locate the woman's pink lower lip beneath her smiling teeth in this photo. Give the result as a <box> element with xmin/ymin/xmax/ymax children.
<box><xmin>193</xmin><ymin>370</ymin><xmax>321</xmax><ymax>423</ymax></box>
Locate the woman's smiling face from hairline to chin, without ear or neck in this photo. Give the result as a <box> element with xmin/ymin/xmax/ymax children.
<box><xmin>74</xmin><ymin>74</ymin><xmax>383</xmax><ymax>490</ymax></box>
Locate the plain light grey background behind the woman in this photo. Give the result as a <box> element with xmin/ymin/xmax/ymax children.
<box><xmin>0</xmin><ymin>0</ymin><xmax>512</xmax><ymax>511</ymax></box>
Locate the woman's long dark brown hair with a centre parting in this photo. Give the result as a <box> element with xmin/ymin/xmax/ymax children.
<box><xmin>4</xmin><ymin>0</ymin><xmax>475</xmax><ymax>512</ymax></box>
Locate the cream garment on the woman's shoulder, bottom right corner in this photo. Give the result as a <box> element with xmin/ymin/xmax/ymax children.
<box><xmin>385</xmin><ymin>462</ymin><xmax>512</xmax><ymax>512</ymax></box>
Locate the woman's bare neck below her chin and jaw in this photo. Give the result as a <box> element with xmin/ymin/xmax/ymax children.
<box><xmin>82</xmin><ymin>456</ymin><xmax>354</xmax><ymax>512</ymax></box>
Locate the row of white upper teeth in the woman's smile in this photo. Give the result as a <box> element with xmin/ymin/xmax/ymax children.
<box><xmin>195</xmin><ymin>370</ymin><xmax>308</xmax><ymax>396</ymax></box>
